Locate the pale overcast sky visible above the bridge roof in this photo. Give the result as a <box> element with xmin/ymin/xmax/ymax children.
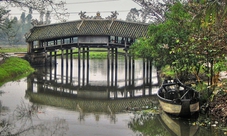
<box><xmin>6</xmin><ymin>0</ymin><xmax>141</xmax><ymax>23</ymax></box>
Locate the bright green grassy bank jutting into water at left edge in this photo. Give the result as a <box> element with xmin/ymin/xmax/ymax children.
<box><xmin>0</xmin><ymin>57</ymin><xmax>34</xmax><ymax>86</ymax></box>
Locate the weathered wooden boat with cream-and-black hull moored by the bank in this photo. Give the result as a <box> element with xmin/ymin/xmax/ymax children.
<box><xmin>157</xmin><ymin>79</ymin><xmax>199</xmax><ymax>116</ymax></box>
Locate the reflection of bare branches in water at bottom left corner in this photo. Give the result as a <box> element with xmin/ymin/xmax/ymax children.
<box><xmin>0</xmin><ymin>101</ymin><xmax>68</xmax><ymax>136</ymax></box>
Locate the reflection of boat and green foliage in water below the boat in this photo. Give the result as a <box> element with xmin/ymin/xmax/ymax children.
<box><xmin>129</xmin><ymin>112</ymin><xmax>199</xmax><ymax>136</ymax></box>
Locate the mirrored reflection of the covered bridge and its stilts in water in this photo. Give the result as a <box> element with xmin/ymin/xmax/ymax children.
<box><xmin>26</xmin><ymin>59</ymin><xmax>158</xmax><ymax>114</ymax></box>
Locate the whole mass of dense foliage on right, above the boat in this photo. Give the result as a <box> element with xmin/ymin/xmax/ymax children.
<box><xmin>131</xmin><ymin>0</ymin><xmax>227</xmax><ymax>84</ymax></box>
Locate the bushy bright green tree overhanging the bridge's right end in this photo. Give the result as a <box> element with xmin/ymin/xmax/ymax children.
<box><xmin>131</xmin><ymin>2</ymin><xmax>198</xmax><ymax>78</ymax></box>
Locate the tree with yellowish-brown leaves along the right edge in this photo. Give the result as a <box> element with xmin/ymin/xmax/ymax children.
<box><xmin>187</xmin><ymin>0</ymin><xmax>227</xmax><ymax>85</ymax></box>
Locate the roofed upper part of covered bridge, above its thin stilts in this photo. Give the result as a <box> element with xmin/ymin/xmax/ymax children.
<box><xmin>26</xmin><ymin>11</ymin><xmax>149</xmax><ymax>65</ymax></box>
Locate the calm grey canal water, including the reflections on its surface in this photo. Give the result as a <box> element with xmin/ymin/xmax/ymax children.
<box><xmin>0</xmin><ymin>59</ymin><xmax>224</xmax><ymax>136</ymax></box>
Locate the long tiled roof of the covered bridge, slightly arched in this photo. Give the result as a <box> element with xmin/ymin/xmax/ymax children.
<box><xmin>26</xmin><ymin>19</ymin><xmax>149</xmax><ymax>42</ymax></box>
